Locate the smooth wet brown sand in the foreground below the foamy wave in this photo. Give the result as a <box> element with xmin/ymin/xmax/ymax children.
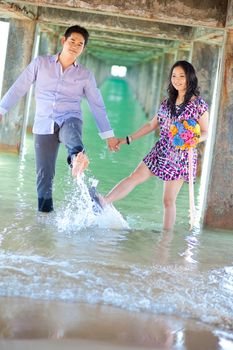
<box><xmin>0</xmin><ymin>298</ymin><xmax>224</xmax><ymax>350</ymax></box>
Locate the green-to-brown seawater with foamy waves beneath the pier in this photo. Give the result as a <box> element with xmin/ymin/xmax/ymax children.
<box><xmin>0</xmin><ymin>76</ymin><xmax>233</xmax><ymax>350</ymax></box>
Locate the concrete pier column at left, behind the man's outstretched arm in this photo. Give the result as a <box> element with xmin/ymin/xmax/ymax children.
<box><xmin>0</xmin><ymin>19</ymin><xmax>36</xmax><ymax>153</ymax></box>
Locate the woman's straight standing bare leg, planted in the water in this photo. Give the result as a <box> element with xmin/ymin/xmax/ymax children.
<box><xmin>163</xmin><ymin>180</ymin><xmax>184</xmax><ymax>230</ymax></box>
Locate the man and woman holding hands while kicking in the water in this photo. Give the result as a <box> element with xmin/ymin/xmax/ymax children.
<box><xmin>0</xmin><ymin>25</ymin><xmax>208</xmax><ymax>230</ymax></box>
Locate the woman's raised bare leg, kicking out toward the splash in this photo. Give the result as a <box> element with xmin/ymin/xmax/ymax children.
<box><xmin>103</xmin><ymin>162</ymin><xmax>153</xmax><ymax>204</ymax></box>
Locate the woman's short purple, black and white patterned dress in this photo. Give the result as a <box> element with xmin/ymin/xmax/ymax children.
<box><xmin>143</xmin><ymin>96</ymin><xmax>208</xmax><ymax>182</ymax></box>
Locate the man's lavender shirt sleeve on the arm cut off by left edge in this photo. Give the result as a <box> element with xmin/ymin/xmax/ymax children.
<box><xmin>0</xmin><ymin>58</ymin><xmax>38</xmax><ymax>114</ymax></box>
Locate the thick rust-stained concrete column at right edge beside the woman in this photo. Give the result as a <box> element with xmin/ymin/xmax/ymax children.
<box><xmin>204</xmin><ymin>29</ymin><xmax>233</xmax><ymax>230</ymax></box>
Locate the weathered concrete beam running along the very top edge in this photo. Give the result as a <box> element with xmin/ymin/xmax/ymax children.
<box><xmin>1</xmin><ymin>0</ymin><xmax>228</xmax><ymax>28</ymax></box>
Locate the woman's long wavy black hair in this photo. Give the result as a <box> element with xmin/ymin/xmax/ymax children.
<box><xmin>167</xmin><ymin>61</ymin><xmax>200</xmax><ymax>115</ymax></box>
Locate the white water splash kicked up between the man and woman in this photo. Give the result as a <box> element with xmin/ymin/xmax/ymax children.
<box><xmin>55</xmin><ymin>174</ymin><xmax>129</xmax><ymax>231</ymax></box>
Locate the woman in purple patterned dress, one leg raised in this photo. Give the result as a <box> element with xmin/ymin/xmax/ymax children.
<box><xmin>100</xmin><ymin>61</ymin><xmax>208</xmax><ymax>230</ymax></box>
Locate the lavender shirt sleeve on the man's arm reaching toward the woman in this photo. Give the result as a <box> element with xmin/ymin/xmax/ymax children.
<box><xmin>84</xmin><ymin>72</ymin><xmax>114</xmax><ymax>139</ymax></box>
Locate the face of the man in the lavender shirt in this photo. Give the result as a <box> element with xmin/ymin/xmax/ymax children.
<box><xmin>61</xmin><ymin>33</ymin><xmax>85</xmax><ymax>60</ymax></box>
